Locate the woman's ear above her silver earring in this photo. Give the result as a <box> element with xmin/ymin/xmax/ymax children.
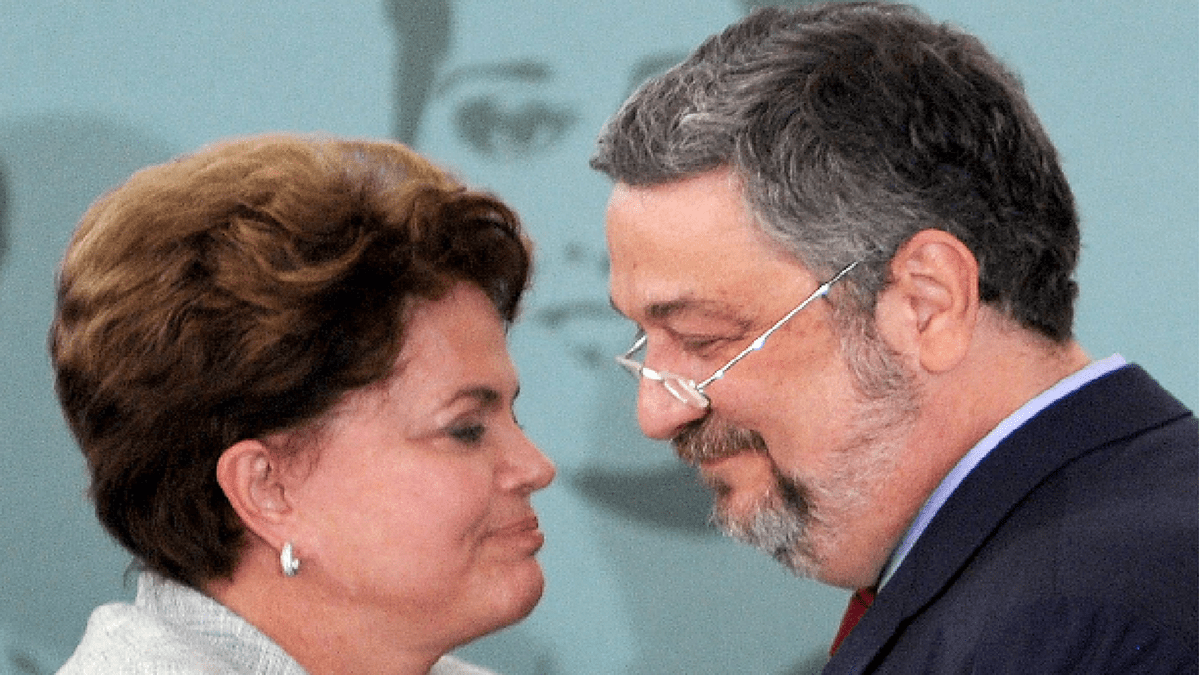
<box><xmin>217</xmin><ymin>438</ymin><xmax>294</xmax><ymax>549</ymax></box>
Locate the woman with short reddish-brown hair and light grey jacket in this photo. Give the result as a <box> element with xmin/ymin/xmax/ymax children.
<box><xmin>50</xmin><ymin>136</ymin><xmax>554</xmax><ymax>675</ymax></box>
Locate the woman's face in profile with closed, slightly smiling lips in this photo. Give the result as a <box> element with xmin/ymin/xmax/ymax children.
<box><xmin>285</xmin><ymin>283</ymin><xmax>554</xmax><ymax>649</ymax></box>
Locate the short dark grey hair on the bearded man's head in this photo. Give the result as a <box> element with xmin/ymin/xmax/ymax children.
<box><xmin>592</xmin><ymin>2</ymin><xmax>1079</xmax><ymax>341</ymax></box>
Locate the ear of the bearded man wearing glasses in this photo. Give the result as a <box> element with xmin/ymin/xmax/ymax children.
<box><xmin>876</xmin><ymin>229</ymin><xmax>979</xmax><ymax>374</ymax></box>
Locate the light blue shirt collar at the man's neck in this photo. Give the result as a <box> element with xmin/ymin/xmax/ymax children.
<box><xmin>880</xmin><ymin>354</ymin><xmax>1126</xmax><ymax>589</ymax></box>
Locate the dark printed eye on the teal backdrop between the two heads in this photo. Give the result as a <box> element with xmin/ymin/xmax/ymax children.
<box><xmin>454</xmin><ymin>96</ymin><xmax>576</xmax><ymax>160</ymax></box>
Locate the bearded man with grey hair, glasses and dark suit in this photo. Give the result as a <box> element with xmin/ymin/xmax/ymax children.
<box><xmin>592</xmin><ymin>2</ymin><xmax>1198</xmax><ymax>673</ymax></box>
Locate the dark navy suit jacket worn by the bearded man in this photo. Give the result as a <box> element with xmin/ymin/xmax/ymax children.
<box><xmin>824</xmin><ymin>366</ymin><xmax>1198</xmax><ymax>675</ymax></box>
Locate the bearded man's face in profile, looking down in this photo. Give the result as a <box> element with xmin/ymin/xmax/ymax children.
<box><xmin>607</xmin><ymin>172</ymin><xmax>916</xmax><ymax>586</ymax></box>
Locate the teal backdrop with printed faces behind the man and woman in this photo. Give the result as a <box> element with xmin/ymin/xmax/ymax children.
<box><xmin>0</xmin><ymin>0</ymin><xmax>1198</xmax><ymax>675</ymax></box>
